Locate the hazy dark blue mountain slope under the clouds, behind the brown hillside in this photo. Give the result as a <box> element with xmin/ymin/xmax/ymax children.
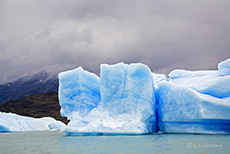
<box><xmin>0</xmin><ymin>71</ymin><xmax>58</xmax><ymax>104</ymax></box>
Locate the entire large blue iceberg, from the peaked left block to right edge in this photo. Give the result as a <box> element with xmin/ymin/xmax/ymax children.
<box><xmin>59</xmin><ymin>59</ymin><xmax>230</xmax><ymax>135</ymax></box>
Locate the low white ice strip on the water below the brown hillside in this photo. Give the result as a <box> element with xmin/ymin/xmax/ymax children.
<box><xmin>0</xmin><ymin>112</ymin><xmax>66</xmax><ymax>132</ymax></box>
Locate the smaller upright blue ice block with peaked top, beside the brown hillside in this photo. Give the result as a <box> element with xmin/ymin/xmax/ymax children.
<box><xmin>58</xmin><ymin>67</ymin><xmax>101</xmax><ymax>120</ymax></box>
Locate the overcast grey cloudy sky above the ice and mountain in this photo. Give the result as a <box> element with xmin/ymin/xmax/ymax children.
<box><xmin>0</xmin><ymin>0</ymin><xmax>230</xmax><ymax>84</ymax></box>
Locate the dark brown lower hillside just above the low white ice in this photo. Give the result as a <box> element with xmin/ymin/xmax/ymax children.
<box><xmin>0</xmin><ymin>92</ymin><xmax>68</xmax><ymax>124</ymax></box>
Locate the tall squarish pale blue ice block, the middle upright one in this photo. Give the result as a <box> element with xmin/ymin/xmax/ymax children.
<box><xmin>100</xmin><ymin>63</ymin><xmax>156</xmax><ymax>133</ymax></box>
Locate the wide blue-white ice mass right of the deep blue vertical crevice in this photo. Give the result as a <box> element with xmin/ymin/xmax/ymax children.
<box><xmin>156</xmin><ymin>61</ymin><xmax>230</xmax><ymax>134</ymax></box>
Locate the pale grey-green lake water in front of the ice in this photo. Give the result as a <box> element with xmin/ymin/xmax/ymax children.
<box><xmin>0</xmin><ymin>131</ymin><xmax>230</xmax><ymax>154</ymax></box>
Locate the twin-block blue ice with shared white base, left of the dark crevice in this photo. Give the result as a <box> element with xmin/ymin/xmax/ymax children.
<box><xmin>59</xmin><ymin>63</ymin><xmax>156</xmax><ymax>135</ymax></box>
